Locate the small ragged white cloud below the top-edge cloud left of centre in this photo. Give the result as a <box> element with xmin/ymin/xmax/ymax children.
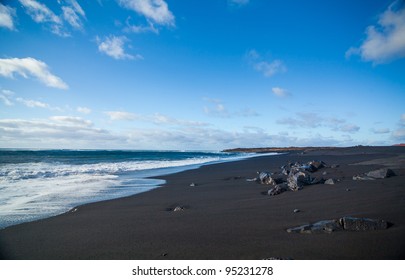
<box><xmin>96</xmin><ymin>35</ymin><xmax>142</xmax><ymax>59</ymax></box>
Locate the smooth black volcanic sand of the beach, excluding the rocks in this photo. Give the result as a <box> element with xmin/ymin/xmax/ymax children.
<box><xmin>0</xmin><ymin>147</ymin><xmax>405</xmax><ymax>259</ymax></box>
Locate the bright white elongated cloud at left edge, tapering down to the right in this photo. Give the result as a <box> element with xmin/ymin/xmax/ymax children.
<box><xmin>0</xmin><ymin>57</ymin><xmax>68</xmax><ymax>89</ymax></box>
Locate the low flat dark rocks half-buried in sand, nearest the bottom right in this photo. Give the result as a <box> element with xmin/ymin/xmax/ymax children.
<box><xmin>287</xmin><ymin>217</ymin><xmax>388</xmax><ymax>233</ymax></box>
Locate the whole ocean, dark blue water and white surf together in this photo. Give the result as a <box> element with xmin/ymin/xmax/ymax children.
<box><xmin>0</xmin><ymin>149</ymin><xmax>253</xmax><ymax>228</ymax></box>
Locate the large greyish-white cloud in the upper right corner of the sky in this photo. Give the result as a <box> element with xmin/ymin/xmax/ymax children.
<box><xmin>346</xmin><ymin>1</ymin><xmax>405</xmax><ymax>64</ymax></box>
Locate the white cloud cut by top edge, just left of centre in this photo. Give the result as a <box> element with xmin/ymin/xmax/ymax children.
<box><xmin>118</xmin><ymin>0</ymin><xmax>175</xmax><ymax>26</ymax></box>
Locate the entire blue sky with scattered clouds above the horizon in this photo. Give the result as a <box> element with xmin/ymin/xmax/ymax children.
<box><xmin>0</xmin><ymin>0</ymin><xmax>405</xmax><ymax>150</ymax></box>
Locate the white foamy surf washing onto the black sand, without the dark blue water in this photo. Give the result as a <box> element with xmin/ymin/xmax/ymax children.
<box><xmin>0</xmin><ymin>157</ymin><xmax>227</xmax><ymax>228</ymax></box>
